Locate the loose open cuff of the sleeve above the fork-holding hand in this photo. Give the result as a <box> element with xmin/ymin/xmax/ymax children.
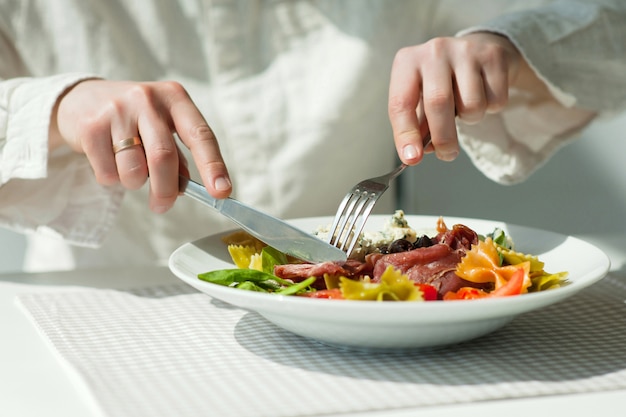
<box><xmin>450</xmin><ymin>20</ymin><xmax>596</xmax><ymax>184</ymax></box>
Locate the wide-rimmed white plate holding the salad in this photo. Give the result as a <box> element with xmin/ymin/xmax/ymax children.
<box><xmin>169</xmin><ymin>215</ymin><xmax>610</xmax><ymax>350</ymax></box>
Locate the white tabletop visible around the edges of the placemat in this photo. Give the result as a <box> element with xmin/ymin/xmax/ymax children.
<box><xmin>0</xmin><ymin>232</ymin><xmax>626</xmax><ymax>417</ymax></box>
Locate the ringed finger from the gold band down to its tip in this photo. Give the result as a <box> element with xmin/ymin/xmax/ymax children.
<box><xmin>112</xmin><ymin>135</ymin><xmax>148</xmax><ymax>190</ymax></box>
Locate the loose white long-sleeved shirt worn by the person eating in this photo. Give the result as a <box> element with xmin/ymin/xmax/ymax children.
<box><xmin>0</xmin><ymin>0</ymin><xmax>626</xmax><ymax>270</ymax></box>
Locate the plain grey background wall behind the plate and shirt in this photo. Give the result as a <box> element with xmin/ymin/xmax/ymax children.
<box><xmin>0</xmin><ymin>114</ymin><xmax>626</xmax><ymax>272</ymax></box>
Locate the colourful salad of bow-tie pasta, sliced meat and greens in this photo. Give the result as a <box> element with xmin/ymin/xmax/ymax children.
<box><xmin>198</xmin><ymin>210</ymin><xmax>567</xmax><ymax>301</ymax></box>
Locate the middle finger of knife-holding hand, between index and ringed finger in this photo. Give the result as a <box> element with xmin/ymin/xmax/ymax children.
<box><xmin>139</xmin><ymin>109</ymin><xmax>180</xmax><ymax>213</ymax></box>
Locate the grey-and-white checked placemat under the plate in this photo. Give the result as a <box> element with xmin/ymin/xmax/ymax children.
<box><xmin>18</xmin><ymin>274</ymin><xmax>626</xmax><ymax>417</ymax></box>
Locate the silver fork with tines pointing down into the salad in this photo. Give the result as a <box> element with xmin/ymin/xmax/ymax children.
<box><xmin>326</xmin><ymin>133</ymin><xmax>430</xmax><ymax>256</ymax></box>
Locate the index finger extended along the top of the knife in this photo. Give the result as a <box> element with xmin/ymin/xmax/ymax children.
<box><xmin>163</xmin><ymin>85</ymin><xmax>232</xmax><ymax>198</ymax></box>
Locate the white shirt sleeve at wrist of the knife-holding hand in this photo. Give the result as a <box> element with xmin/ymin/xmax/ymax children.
<box><xmin>0</xmin><ymin>74</ymin><xmax>123</xmax><ymax>246</ymax></box>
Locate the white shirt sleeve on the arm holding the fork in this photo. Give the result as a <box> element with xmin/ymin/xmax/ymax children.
<box><xmin>457</xmin><ymin>0</ymin><xmax>626</xmax><ymax>184</ymax></box>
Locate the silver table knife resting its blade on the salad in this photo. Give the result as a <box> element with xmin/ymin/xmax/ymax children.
<box><xmin>179</xmin><ymin>175</ymin><xmax>347</xmax><ymax>263</ymax></box>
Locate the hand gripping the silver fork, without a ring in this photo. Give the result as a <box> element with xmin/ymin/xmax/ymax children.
<box><xmin>389</xmin><ymin>32</ymin><xmax>528</xmax><ymax>165</ymax></box>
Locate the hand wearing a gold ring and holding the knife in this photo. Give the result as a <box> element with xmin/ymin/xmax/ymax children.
<box><xmin>50</xmin><ymin>80</ymin><xmax>232</xmax><ymax>213</ymax></box>
